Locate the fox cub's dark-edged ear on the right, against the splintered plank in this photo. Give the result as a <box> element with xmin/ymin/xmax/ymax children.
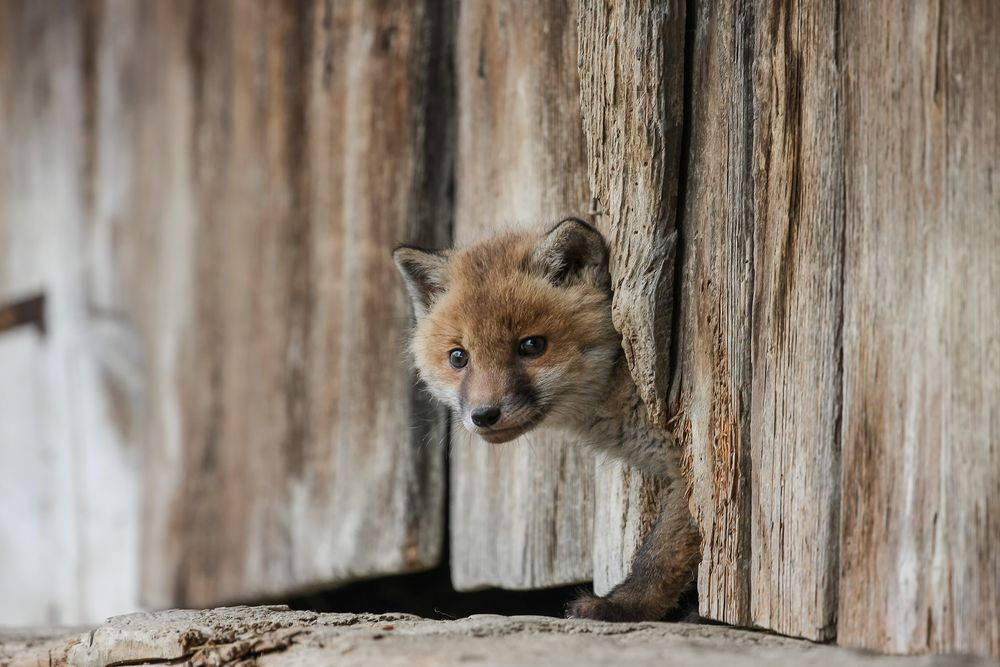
<box><xmin>531</xmin><ymin>218</ymin><xmax>611</xmax><ymax>290</ymax></box>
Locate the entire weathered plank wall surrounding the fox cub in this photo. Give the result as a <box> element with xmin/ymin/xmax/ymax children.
<box><xmin>0</xmin><ymin>0</ymin><xmax>1000</xmax><ymax>656</ymax></box>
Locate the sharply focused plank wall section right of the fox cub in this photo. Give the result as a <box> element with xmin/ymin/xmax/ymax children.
<box><xmin>677</xmin><ymin>0</ymin><xmax>1000</xmax><ymax>655</ymax></box>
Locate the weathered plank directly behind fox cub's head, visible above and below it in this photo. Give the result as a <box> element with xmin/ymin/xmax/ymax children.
<box><xmin>451</xmin><ymin>0</ymin><xmax>594</xmax><ymax>589</ymax></box>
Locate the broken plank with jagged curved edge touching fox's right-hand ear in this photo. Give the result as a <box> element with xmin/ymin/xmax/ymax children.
<box><xmin>578</xmin><ymin>0</ymin><xmax>685</xmax><ymax>594</ymax></box>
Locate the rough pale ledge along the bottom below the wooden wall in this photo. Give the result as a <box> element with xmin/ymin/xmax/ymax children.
<box><xmin>0</xmin><ymin>607</ymin><xmax>1000</xmax><ymax>667</ymax></box>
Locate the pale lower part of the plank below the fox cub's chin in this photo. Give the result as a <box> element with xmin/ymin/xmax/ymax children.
<box><xmin>450</xmin><ymin>428</ymin><xmax>594</xmax><ymax>590</ymax></box>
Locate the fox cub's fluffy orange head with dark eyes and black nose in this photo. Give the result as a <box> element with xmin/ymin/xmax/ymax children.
<box><xmin>394</xmin><ymin>218</ymin><xmax>621</xmax><ymax>442</ymax></box>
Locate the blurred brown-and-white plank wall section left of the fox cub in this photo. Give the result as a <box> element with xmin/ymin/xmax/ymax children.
<box><xmin>0</xmin><ymin>0</ymin><xmax>453</xmax><ymax>623</ymax></box>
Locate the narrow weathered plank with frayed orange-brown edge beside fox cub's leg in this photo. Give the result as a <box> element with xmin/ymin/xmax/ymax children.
<box><xmin>676</xmin><ymin>2</ymin><xmax>754</xmax><ymax>625</ymax></box>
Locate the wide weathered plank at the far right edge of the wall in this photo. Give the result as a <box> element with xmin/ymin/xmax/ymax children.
<box><xmin>838</xmin><ymin>0</ymin><xmax>1000</xmax><ymax>656</ymax></box>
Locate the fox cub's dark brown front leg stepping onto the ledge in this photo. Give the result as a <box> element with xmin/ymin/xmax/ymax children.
<box><xmin>566</xmin><ymin>481</ymin><xmax>701</xmax><ymax>621</ymax></box>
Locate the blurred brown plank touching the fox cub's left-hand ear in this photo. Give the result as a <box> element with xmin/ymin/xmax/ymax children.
<box><xmin>292</xmin><ymin>0</ymin><xmax>454</xmax><ymax>596</ymax></box>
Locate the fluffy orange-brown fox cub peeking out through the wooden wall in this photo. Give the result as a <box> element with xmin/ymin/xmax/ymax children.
<box><xmin>393</xmin><ymin>218</ymin><xmax>700</xmax><ymax>621</ymax></box>
